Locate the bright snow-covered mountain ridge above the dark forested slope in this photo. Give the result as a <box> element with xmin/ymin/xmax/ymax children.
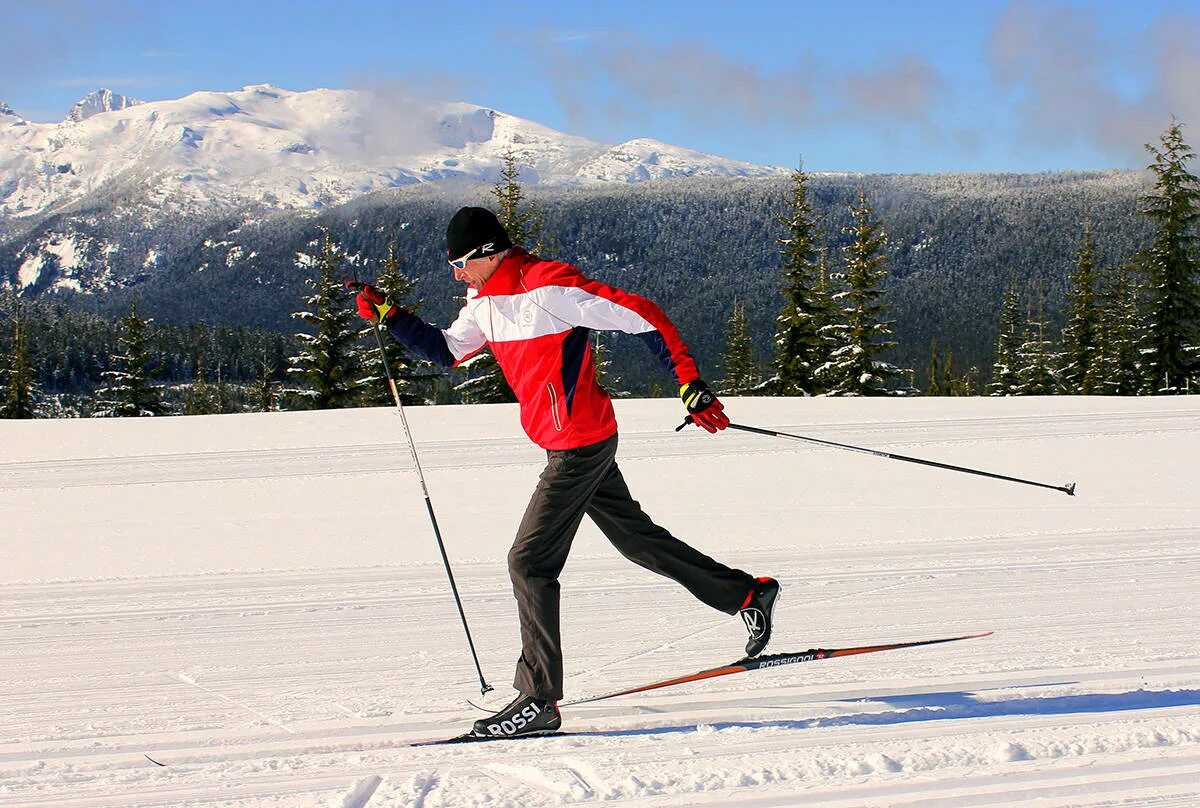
<box><xmin>0</xmin><ymin>84</ymin><xmax>784</xmax><ymax>219</ymax></box>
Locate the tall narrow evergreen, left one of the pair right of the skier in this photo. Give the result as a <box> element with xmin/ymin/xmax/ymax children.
<box><xmin>763</xmin><ymin>169</ymin><xmax>833</xmax><ymax>395</ymax></box>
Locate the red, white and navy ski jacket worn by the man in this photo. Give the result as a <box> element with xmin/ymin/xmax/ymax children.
<box><xmin>389</xmin><ymin>247</ymin><xmax>700</xmax><ymax>449</ymax></box>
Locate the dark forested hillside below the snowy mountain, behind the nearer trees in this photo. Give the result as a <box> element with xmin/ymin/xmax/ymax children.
<box><xmin>2</xmin><ymin>172</ymin><xmax>1148</xmax><ymax>391</ymax></box>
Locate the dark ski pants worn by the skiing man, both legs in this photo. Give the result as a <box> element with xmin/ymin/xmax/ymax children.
<box><xmin>509</xmin><ymin>435</ymin><xmax>755</xmax><ymax>701</ymax></box>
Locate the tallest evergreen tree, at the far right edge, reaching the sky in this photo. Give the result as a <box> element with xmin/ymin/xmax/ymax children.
<box><xmin>1139</xmin><ymin>121</ymin><xmax>1200</xmax><ymax>393</ymax></box>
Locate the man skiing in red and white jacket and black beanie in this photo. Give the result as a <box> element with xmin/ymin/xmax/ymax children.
<box><xmin>356</xmin><ymin>208</ymin><xmax>780</xmax><ymax>737</ymax></box>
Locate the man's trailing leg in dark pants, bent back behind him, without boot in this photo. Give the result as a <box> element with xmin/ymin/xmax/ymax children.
<box><xmin>587</xmin><ymin>451</ymin><xmax>755</xmax><ymax>615</ymax></box>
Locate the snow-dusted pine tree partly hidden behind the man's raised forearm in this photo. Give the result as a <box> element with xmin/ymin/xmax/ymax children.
<box><xmin>362</xmin><ymin>241</ymin><xmax>442</xmax><ymax>407</ymax></box>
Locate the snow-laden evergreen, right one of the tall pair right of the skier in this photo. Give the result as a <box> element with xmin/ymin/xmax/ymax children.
<box><xmin>817</xmin><ymin>190</ymin><xmax>910</xmax><ymax>395</ymax></box>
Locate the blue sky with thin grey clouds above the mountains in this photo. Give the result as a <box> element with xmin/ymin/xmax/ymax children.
<box><xmin>0</xmin><ymin>0</ymin><xmax>1200</xmax><ymax>173</ymax></box>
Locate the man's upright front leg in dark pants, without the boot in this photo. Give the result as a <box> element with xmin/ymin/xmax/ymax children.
<box><xmin>509</xmin><ymin>436</ymin><xmax>617</xmax><ymax>701</ymax></box>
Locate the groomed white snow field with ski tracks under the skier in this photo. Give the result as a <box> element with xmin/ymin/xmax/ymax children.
<box><xmin>0</xmin><ymin>397</ymin><xmax>1200</xmax><ymax>808</ymax></box>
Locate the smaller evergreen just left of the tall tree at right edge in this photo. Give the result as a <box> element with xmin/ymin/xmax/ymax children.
<box><xmin>1087</xmin><ymin>263</ymin><xmax>1144</xmax><ymax>395</ymax></box>
